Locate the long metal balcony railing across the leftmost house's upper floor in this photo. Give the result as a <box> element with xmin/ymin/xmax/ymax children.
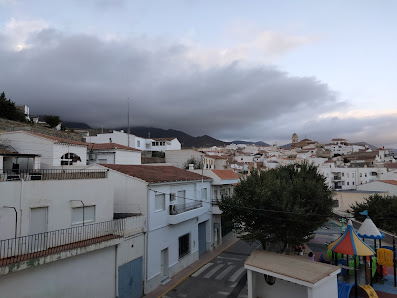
<box><xmin>0</xmin><ymin>218</ymin><xmax>124</xmax><ymax>266</ymax></box>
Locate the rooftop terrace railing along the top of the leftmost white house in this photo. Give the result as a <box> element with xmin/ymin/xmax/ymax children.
<box><xmin>0</xmin><ymin>169</ymin><xmax>107</xmax><ymax>182</ymax></box>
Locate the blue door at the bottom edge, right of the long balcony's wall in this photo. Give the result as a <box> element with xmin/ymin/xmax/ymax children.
<box><xmin>119</xmin><ymin>257</ymin><xmax>143</xmax><ymax>298</ymax></box>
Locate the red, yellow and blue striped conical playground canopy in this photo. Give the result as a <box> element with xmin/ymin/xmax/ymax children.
<box><xmin>328</xmin><ymin>220</ymin><xmax>375</xmax><ymax>256</ymax></box>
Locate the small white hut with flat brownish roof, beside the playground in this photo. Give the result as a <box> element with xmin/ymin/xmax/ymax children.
<box><xmin>244</xmin><ymin>250</ymin><xmax>341</xmax><ymax>298</ymax></box>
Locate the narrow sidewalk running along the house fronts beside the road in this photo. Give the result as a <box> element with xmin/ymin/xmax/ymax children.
<box><xmin>144</xmin><ymin>236</ymin><xmax>239</xmax><ymax>298</ymax></box>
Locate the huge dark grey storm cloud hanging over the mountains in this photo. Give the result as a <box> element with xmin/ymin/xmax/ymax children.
<box><xmin>0</xmin><ymin>29</ymin><xmax>338</xmax><ymax>138</ymax></box>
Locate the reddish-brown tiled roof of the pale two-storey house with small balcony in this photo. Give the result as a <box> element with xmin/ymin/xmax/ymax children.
<box><xmin>102</xmin><ymin>164</ymin><xmax>212</xmax><ymax>183</ymax></box>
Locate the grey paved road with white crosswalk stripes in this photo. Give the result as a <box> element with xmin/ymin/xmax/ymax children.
<box><xmin>165</xmin><ymin>240</ymin><xmax>258</xmax><ymax>298</ymax></box>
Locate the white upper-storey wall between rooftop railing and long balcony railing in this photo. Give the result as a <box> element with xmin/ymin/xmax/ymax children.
<box><xmin>0</xmin><ymin>178</ymin><xmax>113</xmax><ymax>239</ymax></box>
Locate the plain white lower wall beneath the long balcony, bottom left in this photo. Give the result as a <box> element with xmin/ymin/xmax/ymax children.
<box><xmin>0</xmin><ymin>246</ymin><xmax>116</xmax><ymax>298</ymax></box>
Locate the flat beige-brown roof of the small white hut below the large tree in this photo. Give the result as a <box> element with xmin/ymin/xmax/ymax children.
<box><xmin>245</xmin><ymin>250</ymin><xmax>340</xmax><ymax>286</ymax></box>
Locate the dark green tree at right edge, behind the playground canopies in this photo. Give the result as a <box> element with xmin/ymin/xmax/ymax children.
<box><xmin>350</xmin><ymin>194</ymin><xmax>397</xmax><ymax>234</ymax></box>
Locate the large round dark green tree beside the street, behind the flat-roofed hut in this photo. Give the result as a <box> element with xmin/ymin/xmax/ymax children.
<box><xmin>218</xmin><ymin>164</ymin><xmax>333</xmax><ymax>252</ymax></box>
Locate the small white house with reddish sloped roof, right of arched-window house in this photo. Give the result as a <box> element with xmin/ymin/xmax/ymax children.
<box><xmin>87</xmin><ymin>143</ymin><xmax>142</xmax><ymax>165</ymax></box>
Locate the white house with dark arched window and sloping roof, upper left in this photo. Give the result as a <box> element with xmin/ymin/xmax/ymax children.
<box><xmin>0</xmin><ymin>131</ymin><xmax>87</xmax><ymax>168</ymax></box>
